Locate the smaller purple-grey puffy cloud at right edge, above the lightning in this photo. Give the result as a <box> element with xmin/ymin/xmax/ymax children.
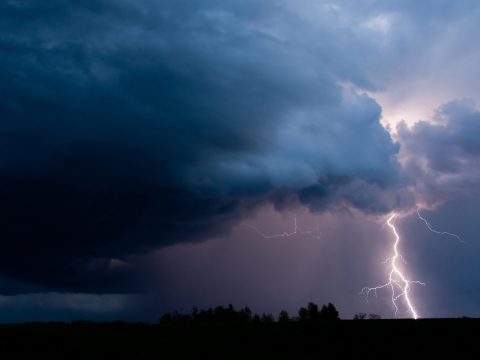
<box><xmin>397</xmin><ymin>99</ymin><xmax>480</xmax><ymax>207</ymax></box>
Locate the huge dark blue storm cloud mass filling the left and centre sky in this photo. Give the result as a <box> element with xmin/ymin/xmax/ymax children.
<box><xmin>0</xmin><ymin>0</ymin><xmax>404</xmax><ymax>292</ymax></box>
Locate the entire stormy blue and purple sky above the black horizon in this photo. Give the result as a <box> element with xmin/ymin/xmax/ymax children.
<box><xmin>0</xmin><ymin>0</ymin><xmax>480</xmax><ymax>322</ymax></box>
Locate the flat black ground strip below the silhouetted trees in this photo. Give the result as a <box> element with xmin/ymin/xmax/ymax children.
<box><xmin>0</xmin><ymin>319</ymin><xmax>480</xmax><ymax>360</ymax></box>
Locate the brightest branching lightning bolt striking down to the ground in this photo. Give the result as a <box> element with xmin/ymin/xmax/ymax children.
<box><xmin>361</xmin><ymin>213</ymin><xmax>425</xmax><ymax>319</ymax></box>
